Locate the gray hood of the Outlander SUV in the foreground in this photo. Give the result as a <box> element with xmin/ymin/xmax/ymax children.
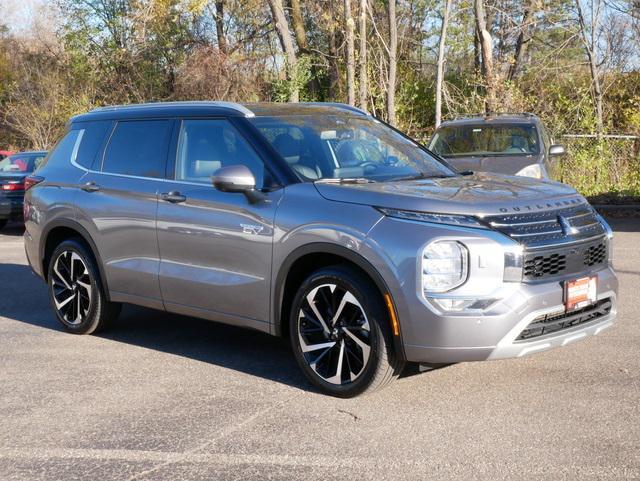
<box><xmin>315</xmin><ymin>173</ymin><xmax>586</xmax><ymax>216</ymax></box>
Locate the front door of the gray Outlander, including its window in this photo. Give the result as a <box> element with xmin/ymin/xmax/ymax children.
<box><xmin>158</xmin><ymin>119</ymin><xmax>282</xmax><ymax>330</ymax></box>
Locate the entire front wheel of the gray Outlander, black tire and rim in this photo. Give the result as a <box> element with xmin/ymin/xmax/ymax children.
<box><xmin>289</xmin><ymin>266</ymin><xmax>404</xmax><ymax>398</ymax></box>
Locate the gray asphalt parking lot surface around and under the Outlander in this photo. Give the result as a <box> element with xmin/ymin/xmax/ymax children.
<box><xmin>0</xmin><ymin>218</ymin><xmax>640</xmax><ymax>481</ymax></box>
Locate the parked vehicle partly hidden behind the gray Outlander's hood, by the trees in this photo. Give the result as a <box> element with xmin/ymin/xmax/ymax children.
<box><xmin>429</xmin><ymin>113</ymin><xmax>565</xmax><ymax>179</ymax></box>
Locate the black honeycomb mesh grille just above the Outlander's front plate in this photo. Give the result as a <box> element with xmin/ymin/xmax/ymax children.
<box><xmin>523</xmin><ymin>240</ymin><xmax>607</xmax><ymax>281</ymax></box>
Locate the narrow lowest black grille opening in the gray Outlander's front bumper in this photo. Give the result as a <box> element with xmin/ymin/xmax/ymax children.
<box><xmin>516</xmin><ymin>299</ymin><xmax>612</xmax><ymax>341</ymax></box>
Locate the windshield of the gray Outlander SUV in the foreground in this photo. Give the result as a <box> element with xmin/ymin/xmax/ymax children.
<box><xmin>250</xmin><ymin>115</ymin><xmax>456</xmax><ymax>182</ymax></box>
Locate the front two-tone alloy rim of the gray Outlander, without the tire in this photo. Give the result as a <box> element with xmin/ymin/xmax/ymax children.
<box><xmin>297</xmin><ymin>284</ymin><xmax>372</xmax><ymax>385</ymax></box>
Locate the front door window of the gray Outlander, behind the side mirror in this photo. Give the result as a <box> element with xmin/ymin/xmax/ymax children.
<box><xmin>176</xmin><ymin>120</ymin><xmax>265</xmax><ymax>189</ymax></box>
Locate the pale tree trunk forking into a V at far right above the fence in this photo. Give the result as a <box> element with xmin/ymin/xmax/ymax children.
<box><xmin>576</xmin><ymin>0</ymin><xmax>604</xmax><ymax>140</ymax></box>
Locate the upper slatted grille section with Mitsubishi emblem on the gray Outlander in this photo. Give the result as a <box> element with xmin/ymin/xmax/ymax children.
<box><xmin>484</xmin><ymin>204</ymin><xmax>606</xmax><ymax>248</ymax></box>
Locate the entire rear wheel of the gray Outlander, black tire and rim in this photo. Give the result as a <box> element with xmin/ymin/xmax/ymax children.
<box><xmin>47</xmin><ymin>239</ymin><xmax>122</xmax><ymax>334</ymax></box>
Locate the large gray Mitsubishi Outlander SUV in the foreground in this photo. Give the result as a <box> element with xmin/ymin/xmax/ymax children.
<box><xmin>24</xmin><ymin>102</ymin><xmax>618</xmax><ymax>397</ymax></box>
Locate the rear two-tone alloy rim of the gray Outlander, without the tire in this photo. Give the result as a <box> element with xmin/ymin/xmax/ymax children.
<box><xmin>51</xmin><ymin>251</ymin><xmax>92</xmax><ymax>325</ymax></box>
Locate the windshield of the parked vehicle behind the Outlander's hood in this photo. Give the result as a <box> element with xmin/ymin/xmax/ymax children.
<box><xmin>429</xmin><ymin>123</ymin><xmax>540</xmax><ymax>158</ymax></box>
